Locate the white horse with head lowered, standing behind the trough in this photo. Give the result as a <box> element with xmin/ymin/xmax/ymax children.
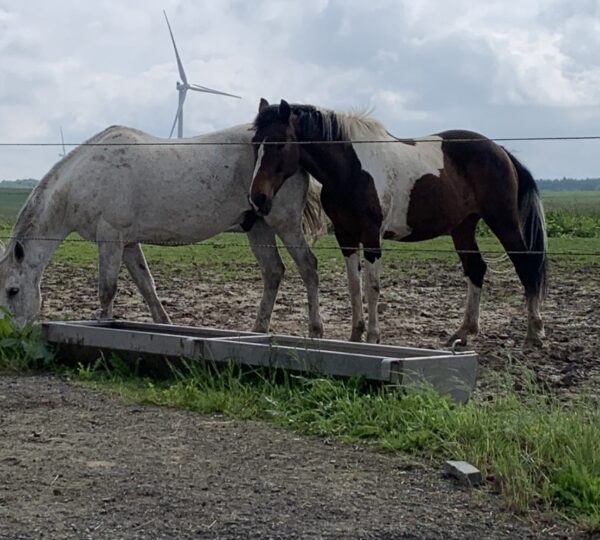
<box><xmin>0</xmin><ymin>125</ymin><xmax>323</xmax><ymax>337</ymax></box>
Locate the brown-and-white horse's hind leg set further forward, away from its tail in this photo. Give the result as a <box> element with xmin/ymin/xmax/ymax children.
<box><xmin>447</xmin><ymin>215</ymin><xmax>487</xmax><ymax>345</ymax></box>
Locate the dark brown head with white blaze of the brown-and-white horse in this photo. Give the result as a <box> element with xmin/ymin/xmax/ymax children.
<box><xmin>248</xmin><ymin>98</ymin><xmax>300</xmax><ymax>216</ymax></box>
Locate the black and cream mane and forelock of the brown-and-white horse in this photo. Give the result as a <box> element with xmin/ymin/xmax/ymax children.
<box><xmin>254</xmin><ymin>104</ymin><xmax>390</xmax><ymax>141</ymax></box>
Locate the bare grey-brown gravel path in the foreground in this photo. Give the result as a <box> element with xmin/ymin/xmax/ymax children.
<box><xmin>0</xmin><ymin>376</ymin><xmax>575</xmax><ymax>540</ymax></box>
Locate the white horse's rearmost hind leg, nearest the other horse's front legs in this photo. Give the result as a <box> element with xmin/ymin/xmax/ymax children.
<box><xmin>277</xmin><ymin>225</ymin><xmax>323</xmax><ymax>338</ymax></box>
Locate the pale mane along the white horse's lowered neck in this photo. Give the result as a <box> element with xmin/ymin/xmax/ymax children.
<box><xmin>12</xmin><ymin>126</ymin><xmax>117</xmax><ymax>238</ymax></box>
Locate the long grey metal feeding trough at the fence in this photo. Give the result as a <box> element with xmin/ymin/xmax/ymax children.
<box><xmin>42</xmin><ymin>320</ymin><xmax>477</xmax><ymax>403</ymax></box>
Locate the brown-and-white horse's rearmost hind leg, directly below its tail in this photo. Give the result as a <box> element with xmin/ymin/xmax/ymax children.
<box><xmin>484</xmin><ymin>214</ymin><xmax>545</xmax><ymax>347</ymax></box>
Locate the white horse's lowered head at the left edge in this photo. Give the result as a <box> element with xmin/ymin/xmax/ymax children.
<box><xmin>0</xmin><ymin>240</ymin><xmax>41</xmax><ymax>323</ymax></box>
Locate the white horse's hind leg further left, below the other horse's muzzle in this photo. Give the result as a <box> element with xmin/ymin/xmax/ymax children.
<box><xmin>248</xmin><ymin>219</ymin><xmax>285</xmax><ymax>333</ymax></box>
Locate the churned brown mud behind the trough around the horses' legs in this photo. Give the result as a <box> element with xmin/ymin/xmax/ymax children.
<box><xmin>43</xmin><ymin>260</ymin><xmax>600</xmax><ymax>399</ymax></box>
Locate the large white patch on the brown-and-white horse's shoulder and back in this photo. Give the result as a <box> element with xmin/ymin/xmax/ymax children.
<box><xmin>352</xmin><ymin>135</ymin><xmax>444</xmax><ymax>239</ymax></box>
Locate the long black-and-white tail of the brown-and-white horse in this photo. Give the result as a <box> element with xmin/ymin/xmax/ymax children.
<box><xmin>504</xmin><ymin>149</ymin><xmax>548</xmax><ymax>300</ymax></box>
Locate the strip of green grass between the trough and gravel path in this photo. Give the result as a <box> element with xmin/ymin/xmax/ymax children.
<box><xmin>69</xmin><ymin>357</ymin><xmax>600</xmax><ymax>532</ymax></box>
